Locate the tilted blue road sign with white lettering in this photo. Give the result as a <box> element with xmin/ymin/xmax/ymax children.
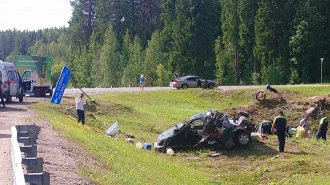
<box><xmin>50</xmin><ymin>66</ymin><xmax>71</xmax><ymax>104</ymax></box>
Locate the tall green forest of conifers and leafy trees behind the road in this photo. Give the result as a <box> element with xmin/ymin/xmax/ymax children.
<box><xmin>0</xmin><ymin>0</ymin><xmax>330</xmax><ymax>87</ymax></box>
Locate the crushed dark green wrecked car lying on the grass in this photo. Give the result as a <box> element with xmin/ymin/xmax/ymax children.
<box><xmin>154</xmin><ymin>110</ymin><xmax>254</xmax><ymax>152</ymax></box>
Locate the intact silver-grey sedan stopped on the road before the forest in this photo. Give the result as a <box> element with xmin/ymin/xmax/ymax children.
<box><xmin>170</xmin><ymin>75</ymin><xmax>216</xmax><ymax>89</ymax></box>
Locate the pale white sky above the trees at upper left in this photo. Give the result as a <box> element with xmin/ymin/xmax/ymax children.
<box><xmin>0</xmin><ymin>0</ymin><xmax>72</xmax><ymax>31</ymax></box>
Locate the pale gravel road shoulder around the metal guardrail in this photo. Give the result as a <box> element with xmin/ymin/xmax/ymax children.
<box><xmin>0</xmin><ymin>97</ymin><xmax>98</xmax><ymax>185</ymax></box>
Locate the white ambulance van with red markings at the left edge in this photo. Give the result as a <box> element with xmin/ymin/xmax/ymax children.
<box><xmin>0</xmin><ymin>60</ymin><xmax>24</xmax><ymax>103</ymax></box>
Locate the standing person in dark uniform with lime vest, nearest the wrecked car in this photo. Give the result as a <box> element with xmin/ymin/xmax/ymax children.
<box><xmin>271</xmin><ymin>110</ymin><xmax>287</xmax><ymax>153</ymax></box>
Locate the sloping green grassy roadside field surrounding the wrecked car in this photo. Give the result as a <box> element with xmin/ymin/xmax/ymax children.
<box><xmin>31</xmin><ymin>87</ymin><xmax>330</xmax><ymax>185</ymax></box>
